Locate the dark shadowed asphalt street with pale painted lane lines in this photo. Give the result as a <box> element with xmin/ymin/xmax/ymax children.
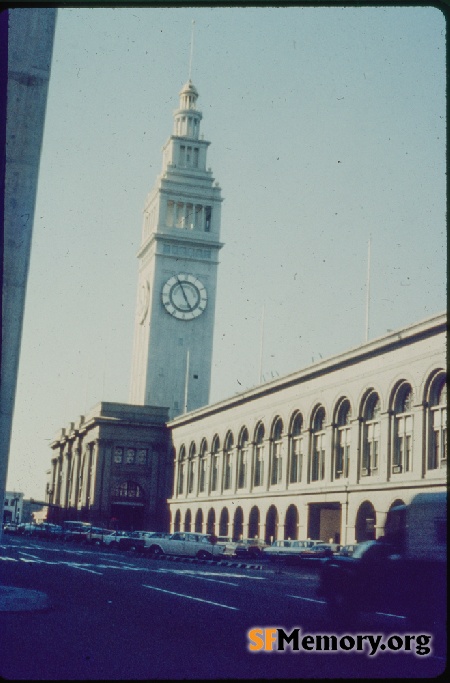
<box><xmin>0</xmin><ymin>537</ymin><xmax>446</xmax><ymax>680</ymax></box>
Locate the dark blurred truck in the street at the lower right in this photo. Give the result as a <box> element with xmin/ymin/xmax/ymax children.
<box><xmin>318</xmin><ymin>492</ymin><xmax>447</xmax><ymax>637</ymax></box>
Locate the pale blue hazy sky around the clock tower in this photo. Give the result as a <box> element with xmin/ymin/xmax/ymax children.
<box><xmin>7</xmin><ymin>6</ymin><xmax>446</xmax><ymax>499</ymax></box>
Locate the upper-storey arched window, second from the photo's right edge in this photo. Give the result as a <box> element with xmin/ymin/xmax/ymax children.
<box><xmin>392</xmin><ymin>383</ymin><xmax>413</xmax><ymax>474</ymax></box>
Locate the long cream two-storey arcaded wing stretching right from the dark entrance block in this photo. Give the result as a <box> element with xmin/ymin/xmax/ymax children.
<box><xmin>168</xmin><ymin>315</ymin><xmax>447</xmax><ymax>543</ymax></box>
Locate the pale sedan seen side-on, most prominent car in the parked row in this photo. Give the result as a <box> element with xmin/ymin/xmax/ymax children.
<box><xmin>148</xmin><ymin>531</ymin><xmax>225</xmax><ymax>560</ymax></box>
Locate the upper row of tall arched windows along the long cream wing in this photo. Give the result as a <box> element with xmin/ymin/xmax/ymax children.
<box><xmin>174</xmin><ymin>371</ymin><xmax>447</xmax><ymax>496</ymax></box>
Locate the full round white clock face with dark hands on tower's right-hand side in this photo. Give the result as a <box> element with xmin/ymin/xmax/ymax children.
<box><xmin>162</xmin><ymin>273</ymin><xmax>208</xmax><ymax>320</ymax></box>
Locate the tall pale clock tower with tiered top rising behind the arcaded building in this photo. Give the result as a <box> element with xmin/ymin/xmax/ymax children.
<box><xmin>130</xmin><ymin>80</ymin><xmax>223</xmax><ymax>418</ymax></box>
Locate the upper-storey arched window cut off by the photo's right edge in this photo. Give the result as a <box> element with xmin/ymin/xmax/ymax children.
<box><xmin>427</xmin><ymin>375</ymin><xmax>447</xmax><ymax>470</ymax></box>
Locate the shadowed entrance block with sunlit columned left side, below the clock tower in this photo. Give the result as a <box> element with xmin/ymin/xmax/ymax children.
<box><xmin>45</xmin><ymin>402</ymin><xmax>172</xmax><ymax>530</ymax></box>
